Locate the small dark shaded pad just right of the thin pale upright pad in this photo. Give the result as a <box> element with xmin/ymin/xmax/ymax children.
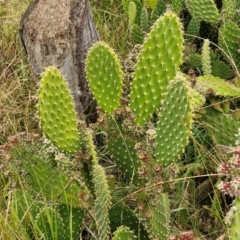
<box><xmin>212</xmin><ymin>60</ymin><xmax>235</xmax><ymax>79</ymax></box>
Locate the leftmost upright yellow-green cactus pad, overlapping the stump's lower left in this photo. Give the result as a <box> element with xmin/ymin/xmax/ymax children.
<box><xmin>38</xmin><ymin>67</ymin><xmax>79</xmax><ymax>152</ymax></box>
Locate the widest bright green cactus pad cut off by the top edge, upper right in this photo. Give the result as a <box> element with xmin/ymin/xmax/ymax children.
<box><xmin>185</xmin><ymin>0</ymin><xmax>219</xmax><ymax>23</ymax></box>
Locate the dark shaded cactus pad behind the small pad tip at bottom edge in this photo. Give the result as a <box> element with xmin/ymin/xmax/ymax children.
<box><xmin>109</xmin><ymin>202</ymin><xmax>149</xmax><ymax>240</ymax></box>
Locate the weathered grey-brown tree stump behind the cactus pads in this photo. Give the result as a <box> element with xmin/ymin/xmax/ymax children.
<box><xmin>19</xmin><ymin>0</ymin><xmax>99</xmax><ymax>117</ymax></box>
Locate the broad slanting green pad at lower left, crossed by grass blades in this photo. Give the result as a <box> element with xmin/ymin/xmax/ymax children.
<box><xmin>23</xmin><ymin>156</ymin><xmax>86</xmax><ymax>208</ymax></box>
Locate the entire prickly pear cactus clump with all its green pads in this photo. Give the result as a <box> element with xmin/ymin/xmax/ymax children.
<box><xmin>11</xmin><ymin>0</ymin><xmax>240</xmax><ymax>240</ymax></box>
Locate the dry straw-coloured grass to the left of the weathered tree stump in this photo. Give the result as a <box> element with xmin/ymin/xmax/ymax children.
<box><xmin>0</xmin><ymin>0</ymin><xmax>38</xmax><ymax>143</ymax></box>
